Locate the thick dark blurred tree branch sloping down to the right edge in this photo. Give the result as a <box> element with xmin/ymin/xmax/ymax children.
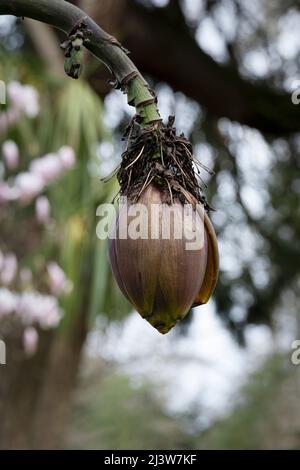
<box><xmin>94</xmin><ymin>0</ymin><xmax>300</xmax><ymax>135</ymax></box>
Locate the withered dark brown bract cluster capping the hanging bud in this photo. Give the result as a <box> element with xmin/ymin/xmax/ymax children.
<box><xmin>118</xmin><ymin>116</ymin><xmax>210</xmax><ymax>210</ymax></box>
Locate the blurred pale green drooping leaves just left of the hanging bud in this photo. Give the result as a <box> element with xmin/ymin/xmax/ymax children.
<box><xmin>52</xmin><ymin>80</ymin><xmax>130</xmax><ymax>324</ymax></box>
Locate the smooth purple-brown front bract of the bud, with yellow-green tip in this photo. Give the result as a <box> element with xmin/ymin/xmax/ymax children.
<box><xmin>109</xmin><ymin>185</ymin><xmax>207</xmax><ymax>333</ymax></box>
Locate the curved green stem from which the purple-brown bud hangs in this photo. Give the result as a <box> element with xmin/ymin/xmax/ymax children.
<box><xmin>0</xmin><ymin>0</ymin><xmax>160</xmax><ymax>125</ymax></box>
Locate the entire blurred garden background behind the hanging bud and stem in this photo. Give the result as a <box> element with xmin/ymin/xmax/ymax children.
<box><xmin>0</xmin><ymin>0</ymin><xmax>300</xmax><ymax>450</ymax></box>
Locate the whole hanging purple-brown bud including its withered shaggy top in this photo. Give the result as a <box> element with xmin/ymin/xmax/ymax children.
<box><xmin>109</xmin><ymin>118</ymin><xmax>219</xmax><ymax>334</ymax></box>
